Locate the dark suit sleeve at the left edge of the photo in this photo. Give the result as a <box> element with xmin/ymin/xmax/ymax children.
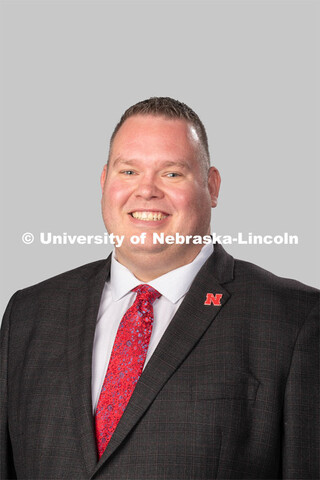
<box><xmin>0</xmin><ymin>294</ymin><xmax>17</xmax><ymax>480</ymax></box>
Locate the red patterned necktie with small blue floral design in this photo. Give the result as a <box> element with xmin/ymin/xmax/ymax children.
<box><xmin>95</xmin><ymin>284</ymin><xmax>161</xmax><ymax>458</ymax></box>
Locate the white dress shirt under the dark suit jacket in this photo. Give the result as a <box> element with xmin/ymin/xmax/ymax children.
<box><xmin>92</xmin><ymin>244</ymin><xmax>213</xmax><ymax>413</ymax></box>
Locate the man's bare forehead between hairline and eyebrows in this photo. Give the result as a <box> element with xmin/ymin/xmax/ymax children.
<box><xmin>110</xmin><ymin>115</ymin><xmax>200</xmax><ymax>159</ymax></box>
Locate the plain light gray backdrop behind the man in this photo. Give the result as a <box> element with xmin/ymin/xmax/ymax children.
<box><xmin>1</xmin><ymin>0</ymin><xmax>319</xmax><ymax>316</ymax></box>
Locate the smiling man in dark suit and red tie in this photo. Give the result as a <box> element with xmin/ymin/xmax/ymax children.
<box><xmin>1</xmin><ymin>98</ymin><xmax>319</xmax><ymax>480</ymax></box>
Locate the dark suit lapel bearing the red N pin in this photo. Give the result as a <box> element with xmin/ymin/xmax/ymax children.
<box><xmin>92</xmin><ymin>245</ymin><xmax>233</xmax><ymax>475</ymax></box>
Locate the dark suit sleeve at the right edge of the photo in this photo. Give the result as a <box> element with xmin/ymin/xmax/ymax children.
<box><xmin>282</xmin><ymin>299</ymin><xmax>320</xmax><ymax>480</ymax></box>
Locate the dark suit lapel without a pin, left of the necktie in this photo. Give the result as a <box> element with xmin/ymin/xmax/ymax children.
<box><xmin>67</xmin><ymin>257</ymin><xmax>110</xmax><ymax>473</ymax></box>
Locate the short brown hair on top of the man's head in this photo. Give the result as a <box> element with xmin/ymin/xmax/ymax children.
<box><xmin>109</xmin><ymin>97</ymin><xmax>210</xmax><ymax>167</ymax></box>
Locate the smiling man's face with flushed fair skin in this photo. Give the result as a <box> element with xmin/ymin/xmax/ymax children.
<box><xmin>101</xmin><ymin>115</ymin><xmax>220</xmax><ymax>271</ymax></box>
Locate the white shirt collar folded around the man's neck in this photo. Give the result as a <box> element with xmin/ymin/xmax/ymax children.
<box><xmin>110</xmin><ymin>243</ymin><xmax>213</xmax><ymax>303</ymax></box>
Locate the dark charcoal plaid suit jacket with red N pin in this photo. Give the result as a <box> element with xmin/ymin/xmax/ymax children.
<box><xmin>1</xmin><ymin>245</ymin><xmax>319</xmax><ymax>480</ymax></box>
